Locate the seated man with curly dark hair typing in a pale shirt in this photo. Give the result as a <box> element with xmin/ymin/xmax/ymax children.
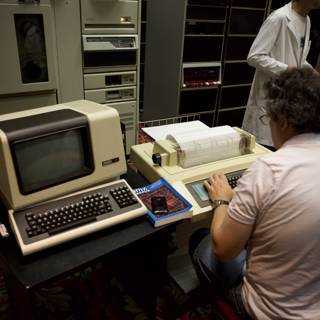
<box><xmin>190</xmin><ymin>69</ymin><xmax>320</xmax><ymax>320</ymax></box>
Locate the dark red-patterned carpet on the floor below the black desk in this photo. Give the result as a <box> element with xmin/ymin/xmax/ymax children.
<box><xmin>0</xmin><ymin>234</ymin><xmax>226</xmax><ymax>320</ymax></box>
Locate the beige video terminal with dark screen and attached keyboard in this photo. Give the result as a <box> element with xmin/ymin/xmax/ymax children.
<box><xmin>0</xmin><ymin>100</ymin><xmax>146</xmax><ymax>254</ymax></box>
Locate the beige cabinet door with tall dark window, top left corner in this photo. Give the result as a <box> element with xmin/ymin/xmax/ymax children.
<box><xmin>0</xmin><ymin>0</ymin><xmax>57</xmax><ymax>97</ymax></box>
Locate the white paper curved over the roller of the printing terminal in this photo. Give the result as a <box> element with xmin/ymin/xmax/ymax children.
<box><xmin>167</xmin><ymin>126</ymin><xmax>241</xmax><ymax>168</ymax></box>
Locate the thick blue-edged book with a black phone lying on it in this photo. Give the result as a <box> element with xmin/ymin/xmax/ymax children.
<box><xmin>134</xmin><ymin>178</ymin><xmax>192</xmax><ymax>227</ymax></box>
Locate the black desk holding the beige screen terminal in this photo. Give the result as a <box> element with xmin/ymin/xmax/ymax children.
<box><xmin>0</xmin><ymin>169</ymin><xmax>172</xmax><ymax>319</ymax></box>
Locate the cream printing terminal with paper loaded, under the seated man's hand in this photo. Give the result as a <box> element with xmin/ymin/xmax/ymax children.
<box><xmin>130</xmin><ymin>126</ymin><xmax>270</xmax><ymax>216</ymax></box>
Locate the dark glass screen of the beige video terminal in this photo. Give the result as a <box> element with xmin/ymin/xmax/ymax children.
<box><xmin>12</xmin><ymin>127</ymin><xmax>93</xmax><ymax>194</ymax></box>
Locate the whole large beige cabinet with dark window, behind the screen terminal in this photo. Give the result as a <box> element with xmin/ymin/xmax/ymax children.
<box><xmin>0</xmin><ymin>0</ymin><xmax>84</xmax><ymax>114</ymax></box>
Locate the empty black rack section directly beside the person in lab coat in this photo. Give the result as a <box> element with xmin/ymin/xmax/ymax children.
<box><xmin>215</xmin><ymin>0</ymin><xmax>268</xmax><ymax>127</ymax></box>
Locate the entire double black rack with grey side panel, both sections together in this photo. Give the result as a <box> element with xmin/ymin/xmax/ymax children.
<box><xmin>143</xmin><ymin>0</ymin><xmax>268</xmax><ymax>126</ymax></box>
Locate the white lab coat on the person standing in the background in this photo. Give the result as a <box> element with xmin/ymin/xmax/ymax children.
<box><xmin>242</xmin><ymin>2</ymin><xmax>311</xmax><ymax>146</ymax></box>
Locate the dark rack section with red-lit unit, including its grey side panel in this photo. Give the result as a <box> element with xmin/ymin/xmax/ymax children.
<box><xmin>143</xmin><ymin>0</ymin><xmax>229</xmax><ymax>125</ymax></box>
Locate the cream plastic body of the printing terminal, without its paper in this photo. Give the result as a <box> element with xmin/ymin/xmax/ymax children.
<box><xmin>130</xmin><ymin>128</ymin><xmax>270</xmax><ymax>216</ymax></box>
